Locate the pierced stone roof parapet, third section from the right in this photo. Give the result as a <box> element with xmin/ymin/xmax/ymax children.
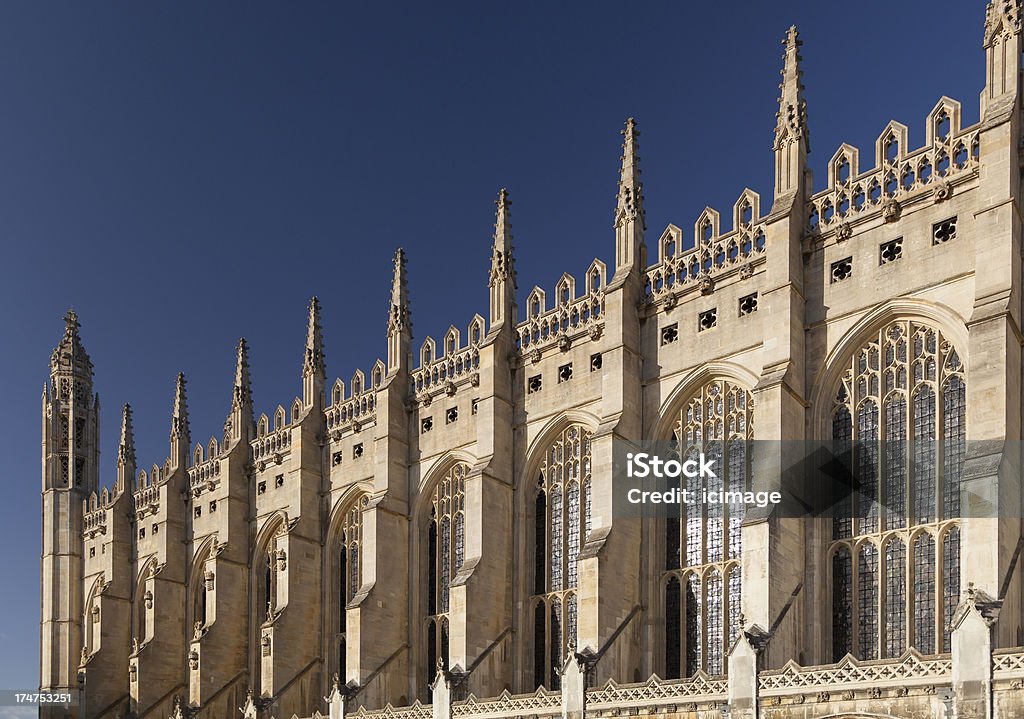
<box><xmin>516</xmin><ymin>259</ymin><xmax>607</xmax><ymax>352</ymax></box>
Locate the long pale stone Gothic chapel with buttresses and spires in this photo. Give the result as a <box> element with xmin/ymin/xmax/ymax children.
<box><xmin>41</xmin><ymin>0</ymin><xmax>1024</xmax><ymax>719</ymax></box>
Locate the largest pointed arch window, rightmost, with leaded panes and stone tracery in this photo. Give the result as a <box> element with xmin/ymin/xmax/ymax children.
<box><xmin>828</xmin><ymin>321</ymin><xmax>966</xmax><ymax>662</ymax></box>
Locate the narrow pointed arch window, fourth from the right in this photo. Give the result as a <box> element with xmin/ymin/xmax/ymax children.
<box><xmin>424</xmin><ymin>463</ymin><xmax>469</xmax><ymax>683</ymax></box>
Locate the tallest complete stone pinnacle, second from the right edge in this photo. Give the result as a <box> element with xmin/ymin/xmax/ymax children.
<box><xmin>775</xmin><ymin>26</ymin><xmax>811</xmax><ymax>209</ymax></box>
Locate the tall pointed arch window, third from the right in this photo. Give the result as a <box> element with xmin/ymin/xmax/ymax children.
<box><xmin>531</xmin><ymin>424</ymin><xmax>591</xmax><ymax>689</ymax></box>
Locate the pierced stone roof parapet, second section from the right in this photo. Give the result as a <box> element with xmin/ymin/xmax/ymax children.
<box><xmin>645</xmin><ymin>189</ymin><xmax>765</xmax><ymax>299</ymax></box>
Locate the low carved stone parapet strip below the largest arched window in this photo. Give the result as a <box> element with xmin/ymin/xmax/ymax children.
<box><xmin>758</xmin><ymin>648</ymin><xmax>952</xmax><ymax>696</ymax></box>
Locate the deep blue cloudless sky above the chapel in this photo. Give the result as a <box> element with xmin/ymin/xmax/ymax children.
<box><xmin>0</xmin><ymin>0</ymin><xmax>984</xmax><ymax>687</ymax></box>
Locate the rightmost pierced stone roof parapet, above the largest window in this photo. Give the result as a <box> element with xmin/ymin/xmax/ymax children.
<box><xmin>806</xmin><ymin>97</ymin><xmax>980</xmax><ymax>234</ymax></box>
